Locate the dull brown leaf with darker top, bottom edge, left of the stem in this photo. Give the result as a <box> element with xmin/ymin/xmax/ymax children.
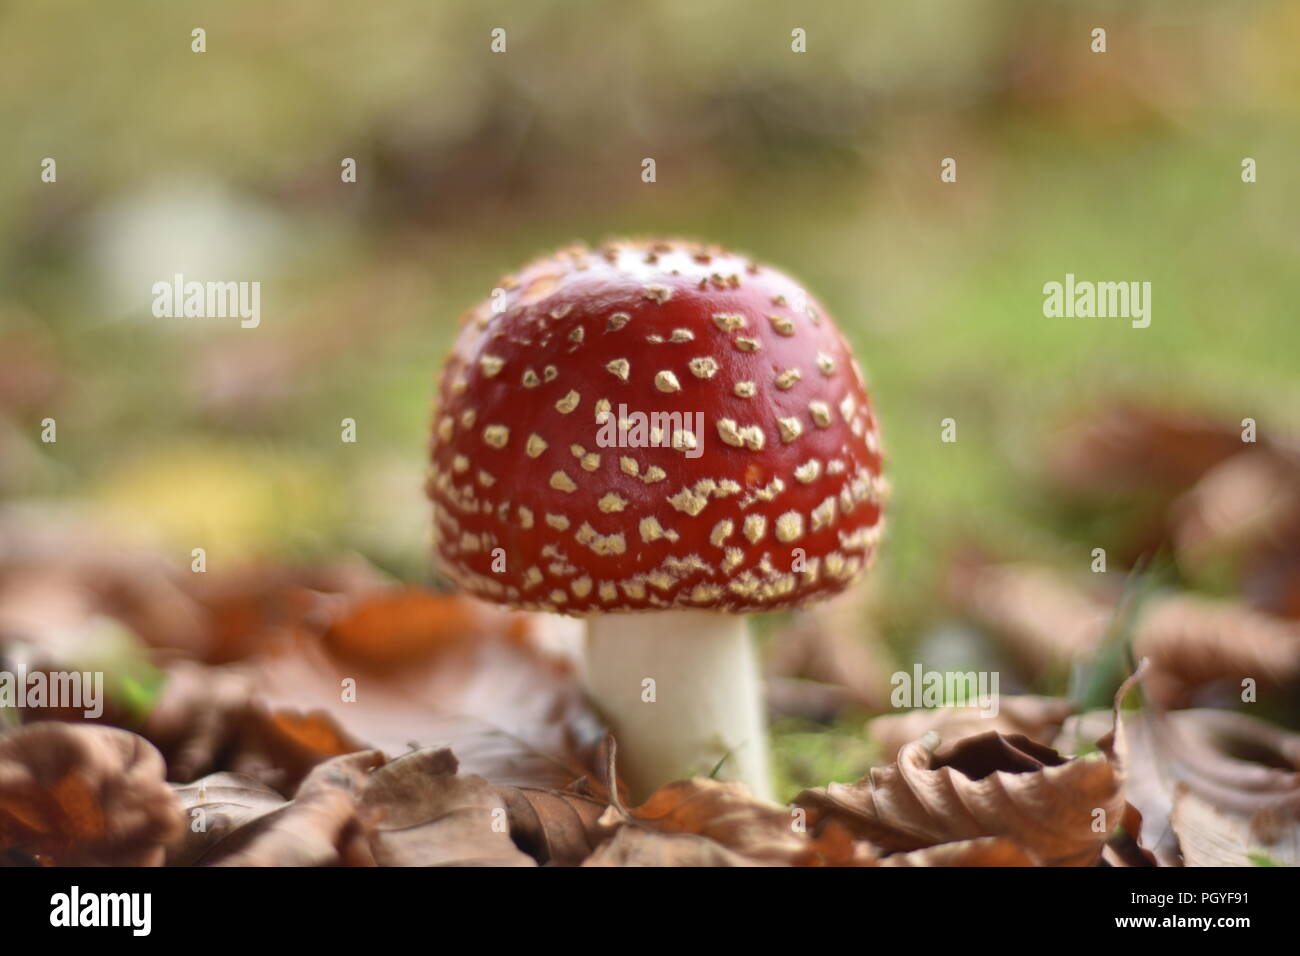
<box><xmin>361</xmin><ymin>749</ymin><xmax>537</xmax><ymax>866</ymax></box>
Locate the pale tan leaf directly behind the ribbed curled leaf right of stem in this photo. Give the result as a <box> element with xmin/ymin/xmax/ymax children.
<box><xmin>867</xmin><ymin>695</ymin><xmax>1071</xmax><ymax>760</ymax></box>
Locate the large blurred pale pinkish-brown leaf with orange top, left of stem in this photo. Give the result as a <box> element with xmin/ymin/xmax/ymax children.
<box><xmin>247</xmin><ymin>592</ymin><xmax>605</xmax><ymax>791</ymax></box>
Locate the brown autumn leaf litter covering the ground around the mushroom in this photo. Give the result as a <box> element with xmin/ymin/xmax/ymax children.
<box><xmin>0</xmin><ymin>406</ymin><xmax>1300</xmax><ymax>866</ymax></box>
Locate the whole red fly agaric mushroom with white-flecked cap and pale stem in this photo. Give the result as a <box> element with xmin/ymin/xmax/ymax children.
<box><xmin>428</xmin><ymin>242</ymin><xmax>885</xmax><ymax>797</ymax></box>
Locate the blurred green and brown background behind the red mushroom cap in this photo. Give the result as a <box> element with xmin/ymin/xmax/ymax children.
<box><xmin>0</xmin><ymin>0</ymin><xmax>1300</xmax><ymax>785</ymax></box>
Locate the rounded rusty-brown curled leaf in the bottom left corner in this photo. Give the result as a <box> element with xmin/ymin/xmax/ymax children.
<box><xmin>0</xmin><ymin>722</ymin><xmax>181</xmax><ymax>866</ymax></box>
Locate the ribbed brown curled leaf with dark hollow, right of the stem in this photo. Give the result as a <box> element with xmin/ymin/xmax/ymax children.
<box><xmin>796</xmin><ymin>732</ymin><xmax>1123</xmax><ymax>866</ymax></box>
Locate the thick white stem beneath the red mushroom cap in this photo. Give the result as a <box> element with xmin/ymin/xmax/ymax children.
<box><xmin>586</xmin><ymin>611</ymin><xmax>772</xmax><ymax>803</ymax></box>
